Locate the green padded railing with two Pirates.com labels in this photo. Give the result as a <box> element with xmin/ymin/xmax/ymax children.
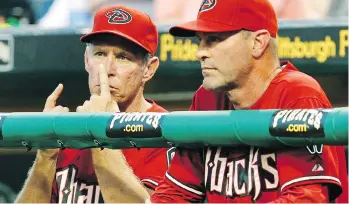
<box><xmin>0</xmin><ymin>107</ymin><xmax>348</xmax><ymax>149</ymax></box>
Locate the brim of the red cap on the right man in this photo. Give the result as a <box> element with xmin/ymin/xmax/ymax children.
<box><xmin>169</xmin><ymin>19</ymin><xmax>242</xmax><ymax>37</ymax></box>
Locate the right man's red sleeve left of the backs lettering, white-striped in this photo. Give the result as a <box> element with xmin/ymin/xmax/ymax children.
<box><xmin>151</xmin><ymin>149</ymin><xmax>205</xmax><ymax>203</ymax></box>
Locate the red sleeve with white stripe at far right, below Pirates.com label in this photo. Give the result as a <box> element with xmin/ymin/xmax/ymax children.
<box><xmin>277</xmin><ymin>97</ymin><xmax>348</xmax><ymax>200</ymax></box>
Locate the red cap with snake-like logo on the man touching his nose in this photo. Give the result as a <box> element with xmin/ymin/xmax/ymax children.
<box><xmin>80</xmin><ymin>6</ymin><xmax>158</xmax><ymax>55</ymax></box>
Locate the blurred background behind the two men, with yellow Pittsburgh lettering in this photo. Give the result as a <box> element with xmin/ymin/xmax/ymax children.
<box><xmin>0</xmin><ymin>0</ymin><xmax>348</xmax><ymax>202</ymax></box>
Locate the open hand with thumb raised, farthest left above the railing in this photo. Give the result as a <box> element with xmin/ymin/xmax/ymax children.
<box><xmin>38</xmin><ymin>84</ymin><xmax>69</xmax><ymax>160</ymax></box>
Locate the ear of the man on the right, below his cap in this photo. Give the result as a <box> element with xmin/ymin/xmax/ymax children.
<box><xmin>252</xmin><ymin>30</ymin><xmax>271</xmax><ymax>59</ymax></box>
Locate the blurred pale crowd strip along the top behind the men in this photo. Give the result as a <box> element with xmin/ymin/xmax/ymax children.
<box><xmin>0</xmin><ymin>0</ymin><xmax>348</xmax><ymax>28</ymax></box>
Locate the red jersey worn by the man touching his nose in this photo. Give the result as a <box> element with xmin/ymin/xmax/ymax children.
<box><xmin>51</xmin><ymin>102</ymin><xmax>173</xmax><ymax>203</ymax></box>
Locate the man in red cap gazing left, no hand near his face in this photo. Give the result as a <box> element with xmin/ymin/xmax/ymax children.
<box><xmin>150</xmin><ymin>0</ymin><xmax>348</xmax><ymax>203</ymax></box>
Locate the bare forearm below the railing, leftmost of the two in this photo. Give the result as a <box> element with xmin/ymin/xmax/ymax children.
<box><xmin>15</xmin><ymin>151</ymin><xmax>56</xmax><ymax>203</ymax></box>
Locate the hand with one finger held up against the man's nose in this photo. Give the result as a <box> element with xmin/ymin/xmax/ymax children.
<box><xmin>76</xmin><ymin>64</ymin><xmax>120</xmax><ymax>112</ymax></box>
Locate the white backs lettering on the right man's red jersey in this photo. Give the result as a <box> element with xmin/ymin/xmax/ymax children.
<box><xmin>205</xmin><ymin>147</ymin><xmax>279</xmax><ymax>201</ymax></box>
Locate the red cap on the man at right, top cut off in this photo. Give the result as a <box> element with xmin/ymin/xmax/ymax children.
<box><xmin>169</xmin><ymin>0</ymin><xmax>278</xmax><ymax>37</ymax></box>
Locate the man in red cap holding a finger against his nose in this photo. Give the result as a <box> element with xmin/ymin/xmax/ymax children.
<box><xmin>16</xmin><ymin>6</ymin><xmax>171</xmax><ymax>203</ymax></box>
